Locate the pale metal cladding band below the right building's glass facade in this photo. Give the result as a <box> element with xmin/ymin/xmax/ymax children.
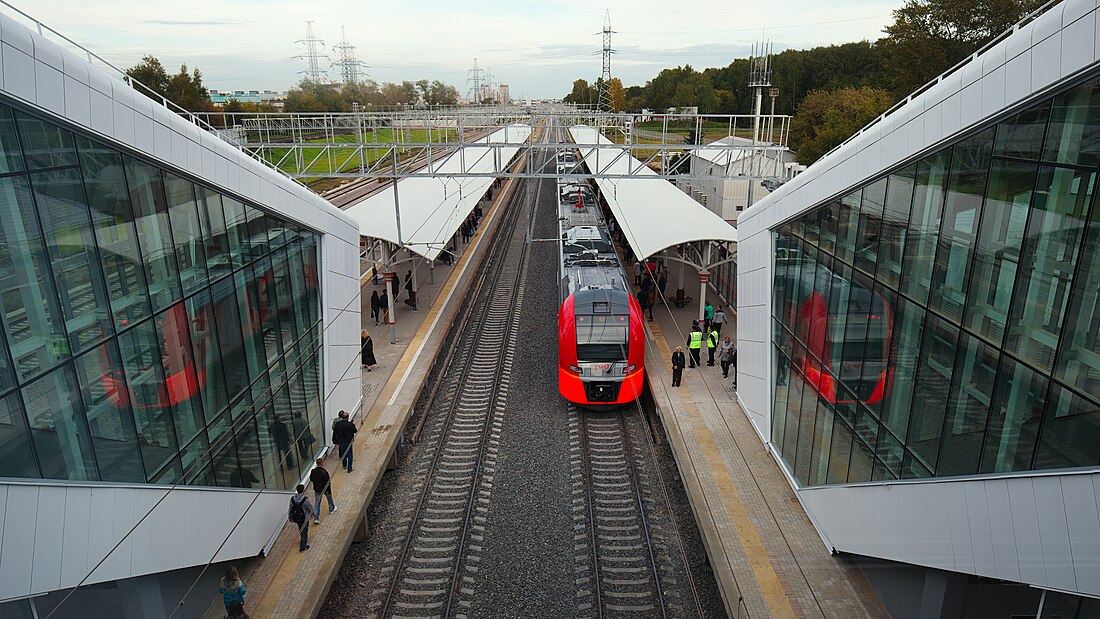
<box><xmin>798</xmin><ymin>472</ymin><xmax>1100</xmax><ymax>596</ymax></box>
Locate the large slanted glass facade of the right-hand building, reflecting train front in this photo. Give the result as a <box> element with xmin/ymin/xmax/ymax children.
<box><xmin>771</xmin><ymin>79</ymin><xmax>1100</xmax><ymax>486</ymax></box>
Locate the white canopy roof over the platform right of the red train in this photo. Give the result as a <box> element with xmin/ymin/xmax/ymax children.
<box><xmin>569</xmin><ymin>125</ymin><xmax>737</xmax><ymax>261</ymax></box>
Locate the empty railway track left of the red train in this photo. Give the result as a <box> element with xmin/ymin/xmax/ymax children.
<box><xmin>367</xmin><ymin>135</ymin><xmax>531</xmax><ymax>618</ymax></box>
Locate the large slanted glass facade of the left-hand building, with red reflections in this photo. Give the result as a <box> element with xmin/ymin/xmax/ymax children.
<box><xmin>0</xmin><ymin>100</ymin><xmax>323</xmax><ymax>488</ymax></box>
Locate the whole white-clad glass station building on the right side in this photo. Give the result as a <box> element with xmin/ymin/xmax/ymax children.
<box><xmin>737</xmin><ymin>1</ymin><xmax>1100</xmax><ymax>617</ymax></box>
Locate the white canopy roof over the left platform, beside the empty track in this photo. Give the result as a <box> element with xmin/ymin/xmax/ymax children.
<box><xmin>344</xmin><ymin>124</ymin><xmax>531</xmax><ymax>259</ymax></box>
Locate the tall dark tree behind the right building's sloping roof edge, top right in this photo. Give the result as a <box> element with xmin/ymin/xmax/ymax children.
<box><xmin>879</xmin><ymin>0</ymin><xmax>1045</xmax><ymax>99</ymax></box>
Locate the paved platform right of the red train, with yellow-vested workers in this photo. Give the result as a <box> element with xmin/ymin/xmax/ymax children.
<box><xmin>646</xmin><ymin>283</ymin><xmax>889</xmax><ymax>618</ymax></box>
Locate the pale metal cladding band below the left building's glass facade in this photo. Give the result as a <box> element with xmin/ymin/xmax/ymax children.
<box><xmin>0</xmin><ymin>483</ymin><xmax>290</xmax><ymax>598</ymax></box>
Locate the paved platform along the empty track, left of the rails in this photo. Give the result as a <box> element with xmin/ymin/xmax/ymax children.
<box><xmin>204</xmin><ymin>177</ymin><xmax>513</xmax><ymax>619</ymax></box>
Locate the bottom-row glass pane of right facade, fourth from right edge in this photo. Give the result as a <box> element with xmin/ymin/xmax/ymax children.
<box><xmin>905</xmin><ymin>316</ymin><xmax>959</xmax><ymax>469</ymax></box>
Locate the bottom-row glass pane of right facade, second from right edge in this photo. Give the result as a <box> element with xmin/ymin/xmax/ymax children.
<box><xmin>981</xmin><ymin>355</ymin><xmax>1048</xmax><ymax>473</ymax></box>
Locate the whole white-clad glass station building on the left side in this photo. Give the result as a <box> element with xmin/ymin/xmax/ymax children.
<box><xmin>0</xmin><ymin>9</ymin><xmax>362</xmax><ymax>617</ymax></box>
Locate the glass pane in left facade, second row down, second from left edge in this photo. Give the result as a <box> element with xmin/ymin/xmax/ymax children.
<box><xmin>31</xmin><ymin>168</ymin><xmax>112</xmax><ymax>352</ymax></box>
